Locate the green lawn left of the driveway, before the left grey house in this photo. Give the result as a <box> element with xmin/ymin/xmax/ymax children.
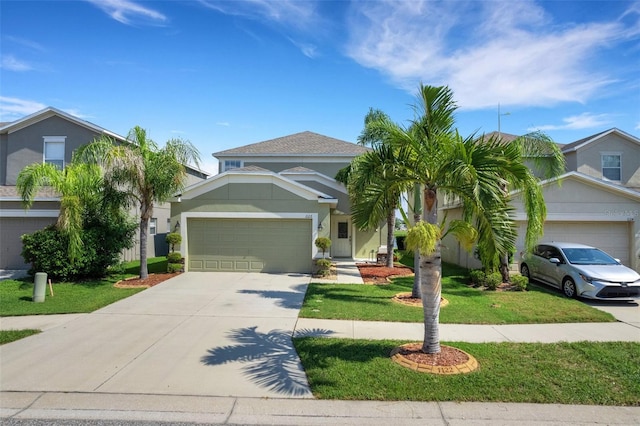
<box><xmin>0</xmin><ymin>257</ymin><xmax>167</xmax><ymax>316</ymax></box>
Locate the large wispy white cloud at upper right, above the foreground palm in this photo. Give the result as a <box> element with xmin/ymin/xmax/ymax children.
<box><xmin>347</xmin><ymin>1</ymin><xmax>635</xmax><ymax>109</ymax></box>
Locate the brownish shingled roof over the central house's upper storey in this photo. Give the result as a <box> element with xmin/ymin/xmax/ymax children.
<box><xmin>213</xmin><ymin>131</ymin><xmax>368</xmax><ymax>158</ymax></box>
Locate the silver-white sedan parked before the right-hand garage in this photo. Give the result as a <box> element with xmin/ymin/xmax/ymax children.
<box><xmin>520</xmin><ymin>242</ymin><xmax>640</xmax><ymax>300</ymax></box>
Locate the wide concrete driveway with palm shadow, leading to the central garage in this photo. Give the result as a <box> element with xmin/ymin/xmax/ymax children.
<box><xmin>0</xmin><ymin>272</ymin><xmax>312</xmax><ymax>398</ymax></box>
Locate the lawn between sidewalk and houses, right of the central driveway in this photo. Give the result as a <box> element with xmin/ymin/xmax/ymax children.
<box><xmin>300</xmin><ymin>264</ymin><xmax>615</xmax><ymax>324</ymax></box>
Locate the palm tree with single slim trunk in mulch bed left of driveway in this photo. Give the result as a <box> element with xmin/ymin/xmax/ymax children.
<box><xmin>77</xmin><ymin>126</ymin><xmax>200</xmax><ymax>279</ymax></box>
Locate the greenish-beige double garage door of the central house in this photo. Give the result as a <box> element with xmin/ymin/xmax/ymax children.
<box><xmin>187</xmin><ymin>219</ymin><xmax>312</xmax><ymax>273</ymax></box>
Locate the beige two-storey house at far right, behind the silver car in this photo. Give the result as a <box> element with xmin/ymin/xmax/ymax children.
<box><xmin>443</xmin><ymin>129</ymin><xmax>640</xmax><ymax>271</ymax></box>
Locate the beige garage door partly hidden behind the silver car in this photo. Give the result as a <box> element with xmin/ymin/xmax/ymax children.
<box><xmin>542</xmin><ymin>222</ymin><xmax>631</xmax><ymax>266</ymax></box>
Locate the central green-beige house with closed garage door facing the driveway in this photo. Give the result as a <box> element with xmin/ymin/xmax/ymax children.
<box><xmin>171</xmin><ymin>132</ymin><xmax>386</xmax><ymax>273</ymax></box>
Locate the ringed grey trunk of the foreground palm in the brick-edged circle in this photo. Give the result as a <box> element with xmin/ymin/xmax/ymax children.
<box><xmin>420</xmin><ymin>188</ymin><xmax>442</xmax><ymax>354</ymax></box>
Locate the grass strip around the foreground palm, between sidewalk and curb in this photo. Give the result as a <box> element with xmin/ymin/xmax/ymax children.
<box><xmin>294</xmin><ymin>338</ymin><xmax>640</xmax><ymax>406</ymax></box>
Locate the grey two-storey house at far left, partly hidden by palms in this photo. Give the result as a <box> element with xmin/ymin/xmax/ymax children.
<box><xmin>0</xmin><ymin>107</ymin><xmax>207</xmax><ymax>269</ymax></box>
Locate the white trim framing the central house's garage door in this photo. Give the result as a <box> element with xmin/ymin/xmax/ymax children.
<box><xmin>180</xmin><ymin>212</ymin><xmax>318</xmax><ymax>271</ymax></box>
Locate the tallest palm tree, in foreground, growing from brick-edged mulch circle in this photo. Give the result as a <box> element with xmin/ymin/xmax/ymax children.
<box><xmin>362</xmin><ymin>85</ymin><xmax>543</xmax><ymax>353</ymax></box>
